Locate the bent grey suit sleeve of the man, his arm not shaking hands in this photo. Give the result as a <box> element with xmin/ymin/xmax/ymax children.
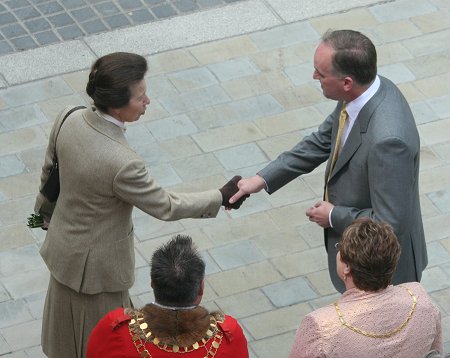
<box><xmin>331</xmin><ymin>137</ymin><xmax>419</xmax><ymax>236</ymax></box>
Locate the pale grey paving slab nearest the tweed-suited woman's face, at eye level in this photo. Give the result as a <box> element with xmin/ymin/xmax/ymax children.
<box><xmin>158</xmin><ymin>86</ymin><xmax>230</xmax><ymax>114</ymax></box>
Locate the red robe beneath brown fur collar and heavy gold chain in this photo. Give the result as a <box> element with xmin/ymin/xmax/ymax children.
<box><xmin>86</xmin><ymin>308</ymin><xmax>248</xmax><ymax>358</ymax></box>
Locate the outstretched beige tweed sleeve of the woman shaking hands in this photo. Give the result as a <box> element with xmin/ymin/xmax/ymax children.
<box><xmin>113</xmin><ymin>159</ymin><xmax>222</xmax><ymax>221</ymax></box>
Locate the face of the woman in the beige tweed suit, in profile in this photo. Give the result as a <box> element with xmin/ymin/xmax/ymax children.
<box><xmin>114</xmin><ymin>80</ymin><xmax>150</xmax><ymax>122</ymax></box>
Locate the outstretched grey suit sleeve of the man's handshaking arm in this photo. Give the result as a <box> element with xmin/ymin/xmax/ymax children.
<box><xmin>258</xmin><ymin>107</ymin><xmax>339</xmax><ymax>194</ymax></box>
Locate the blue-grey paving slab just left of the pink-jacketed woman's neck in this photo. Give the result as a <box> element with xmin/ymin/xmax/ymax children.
<box><xmin>262</xmin><ymin>277</ymin><xmax>318</xmax><ymax>307</ymax></box>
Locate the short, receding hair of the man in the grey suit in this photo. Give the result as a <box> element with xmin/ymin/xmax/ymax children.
<box><xmin>322</xmin><ymin>30</ymin><xmax>377</xmax><ymax>85</ymax></box>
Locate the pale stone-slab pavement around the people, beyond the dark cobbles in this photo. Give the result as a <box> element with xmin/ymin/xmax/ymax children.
<box><xmin>0</xmin><ymin>0</ymin><xmax>450</xmax><ymax>358</ymax></box>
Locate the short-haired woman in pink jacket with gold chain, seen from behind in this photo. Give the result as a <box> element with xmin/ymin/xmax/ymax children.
<box><xmin>290</xmin><ymin>219</ymin><xmax>443</xmax><ymax>358</ymax></box>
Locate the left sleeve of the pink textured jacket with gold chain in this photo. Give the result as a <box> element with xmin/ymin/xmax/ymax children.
<box><xmin>289</xmin><ymin>315</ymin><xmax>326</xmax><ymax>358</ymax></box>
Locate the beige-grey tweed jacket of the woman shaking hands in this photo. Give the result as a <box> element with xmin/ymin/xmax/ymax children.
<box><xmin>35</xmin><ymin>108</ymin><xmax>222</xmax><ymax>294</ymax></box>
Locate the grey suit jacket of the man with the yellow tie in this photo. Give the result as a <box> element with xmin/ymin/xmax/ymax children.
<box><xmin>259</xmin><ymin>77</ymin><xmax>428</xmax><ymax>291</ymax></box>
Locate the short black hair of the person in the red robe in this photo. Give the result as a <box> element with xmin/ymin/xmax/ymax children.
<box><xmin>150</xmin><ymin>235</ymin><xmax>205</xmax><ymax>306</ymax></box>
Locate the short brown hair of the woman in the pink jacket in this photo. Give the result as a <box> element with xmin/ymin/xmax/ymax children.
<box><xmin>339</xmin><ymin>218</ymin><xmax>400</xmax><ymax>291</ymax></box>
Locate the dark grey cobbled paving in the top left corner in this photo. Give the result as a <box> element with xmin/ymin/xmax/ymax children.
<box><xmin>0</xmin><ymin>0</ymin><xmax>246</xmax><ymax>55</ymax></box>
